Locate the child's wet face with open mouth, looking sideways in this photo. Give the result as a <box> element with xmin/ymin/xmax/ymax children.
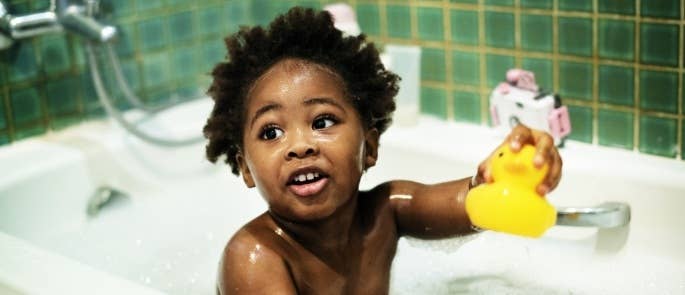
<box><xmin>237</xmin><ymin>60</ymin><xmax>378</xmax><ymax>220</ymax></box>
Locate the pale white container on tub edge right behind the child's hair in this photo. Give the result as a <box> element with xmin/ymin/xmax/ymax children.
<box><xmin>381</xmin><ymin>45</ymin><xmax>421</xmax><ymax>126</ymax></box>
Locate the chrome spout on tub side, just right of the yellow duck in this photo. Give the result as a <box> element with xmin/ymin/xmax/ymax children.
<box><xmin>557</xmin><ymin>202</ymin><xmax>630</xmax><ymax>228</ymax></box>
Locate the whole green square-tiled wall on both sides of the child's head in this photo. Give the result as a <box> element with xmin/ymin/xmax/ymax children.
<box><xmin>0</xmin><ymin>0</ymin><xmax>685</xmax><ymax>159</ymax></box>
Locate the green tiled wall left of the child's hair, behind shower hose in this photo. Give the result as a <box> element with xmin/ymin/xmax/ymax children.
<box><xmin>0</xmin><ymin>0</ymin><xmax>254</xmax><ymax>145</ymax></box>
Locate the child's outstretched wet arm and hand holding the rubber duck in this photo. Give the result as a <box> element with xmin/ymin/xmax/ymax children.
<box><xmin>378</xmin><ymin>125</ymin><xmax>562</xmax><ymax>238</ymax></box>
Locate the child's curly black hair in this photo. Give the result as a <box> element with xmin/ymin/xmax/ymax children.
<box><xmin>203</xmin><ymin>7</ymin><xmax>399</xmax><ymax>175</ymax></box>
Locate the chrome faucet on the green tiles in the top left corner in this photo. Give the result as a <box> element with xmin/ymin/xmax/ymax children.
<box><xmin>0</xmin><ymin>0</ymin><xmax>117</xmax><ymax>49</ymax></box>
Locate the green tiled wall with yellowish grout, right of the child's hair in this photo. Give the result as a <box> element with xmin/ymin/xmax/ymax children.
<box><xmin>351</xmin><ymin>0</ymin><xmax>685</xmax><ymax>159</ymax></box>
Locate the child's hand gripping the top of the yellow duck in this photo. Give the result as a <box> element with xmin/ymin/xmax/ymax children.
<box><xmin>475</xmin><ymin>124</ymin><xmax>562</xmax><ymax>196</ymax></box>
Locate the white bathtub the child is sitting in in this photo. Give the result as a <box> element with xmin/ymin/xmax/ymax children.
<box><xmin>0</xmin><ymin>100</ymin><xmax>685</xmax><ymax>294</ymax></box>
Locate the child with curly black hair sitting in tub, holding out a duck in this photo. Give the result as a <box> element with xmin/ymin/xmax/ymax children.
<box><xmin>204</xmin><ymin>8</ymin><xmax>561</xmax><ymax>294</ymax></box>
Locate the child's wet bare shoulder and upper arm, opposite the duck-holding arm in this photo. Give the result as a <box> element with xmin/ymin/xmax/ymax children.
<box><xmin>217</xmin><ymin>216</ymin><xmax>296</xmax><ymax>294</ymax></box>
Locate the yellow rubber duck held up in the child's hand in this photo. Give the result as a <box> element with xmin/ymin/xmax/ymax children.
<box><xmin>466</xmin><ymin>145</ymin><xmax>557</xmax><ymax>237</ymax></box>
